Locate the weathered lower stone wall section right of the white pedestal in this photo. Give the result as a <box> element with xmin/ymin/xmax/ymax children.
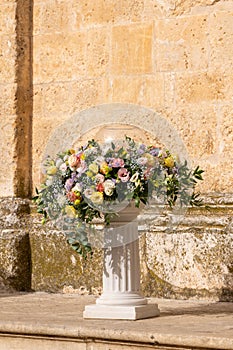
<box><xmin>141</xmin><ymin>196</ymin><xmax>233</xmax><ymax>301</ymax></box>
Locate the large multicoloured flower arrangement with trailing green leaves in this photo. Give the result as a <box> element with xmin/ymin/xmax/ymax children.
<box><xmin>33</xmin><ymin>136</ymin><xmax>203</xmax><ymax>257</ymax></box>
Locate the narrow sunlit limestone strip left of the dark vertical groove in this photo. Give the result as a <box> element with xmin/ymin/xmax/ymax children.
<box><xmin>0</xmin><ymin>2</ymin><xmax>16</xmax><ymax>195</ymax></box>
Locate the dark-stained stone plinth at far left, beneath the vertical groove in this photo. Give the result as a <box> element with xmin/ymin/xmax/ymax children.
<box><xmin>0</xmin><ymin>197</ymin><xmax>31</xmax><ymax>291</ymax></box>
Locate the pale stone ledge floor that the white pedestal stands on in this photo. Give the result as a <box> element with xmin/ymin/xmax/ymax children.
<box><xmin>0</xmin><ymin>293</ymin><xmax>233</xmax><ymax>349</ymax></box>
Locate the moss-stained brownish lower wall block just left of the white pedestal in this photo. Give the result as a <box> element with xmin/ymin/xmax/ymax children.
<box><xmin>30</xmin><ymin>221</ymin><xmax>102</xmax><ymax>292</ymax></box>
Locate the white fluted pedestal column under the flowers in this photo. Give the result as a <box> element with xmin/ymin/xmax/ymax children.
<box><xmin>83</xmin><ymin>217</ymin><xmax>159</xmax><ymax>320</ymax></box>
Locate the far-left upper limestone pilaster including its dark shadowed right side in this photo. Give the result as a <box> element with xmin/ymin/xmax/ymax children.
<box><xmin>0</xmin><ymin>0</ymin><xmax>32</xmax><ymax>197</ymax></box>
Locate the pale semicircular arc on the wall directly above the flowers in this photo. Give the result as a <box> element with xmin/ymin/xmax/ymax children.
<box><xmin>44</xmin><ymin>103</ymin><xmax>189</xmax><ymax>166</ymax></box>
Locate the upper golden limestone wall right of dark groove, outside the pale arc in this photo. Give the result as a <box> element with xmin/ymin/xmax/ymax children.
<box><xmin>33</xmin><ymin>0</ymin><xmax>233</xmax><ymax>193</ymax></box>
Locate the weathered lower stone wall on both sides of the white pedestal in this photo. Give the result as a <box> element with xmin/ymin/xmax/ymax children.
<box><xmin>25</xmin><ymin>195</ymin><xmax>233</xmax><ymax>301</ymax></box>
